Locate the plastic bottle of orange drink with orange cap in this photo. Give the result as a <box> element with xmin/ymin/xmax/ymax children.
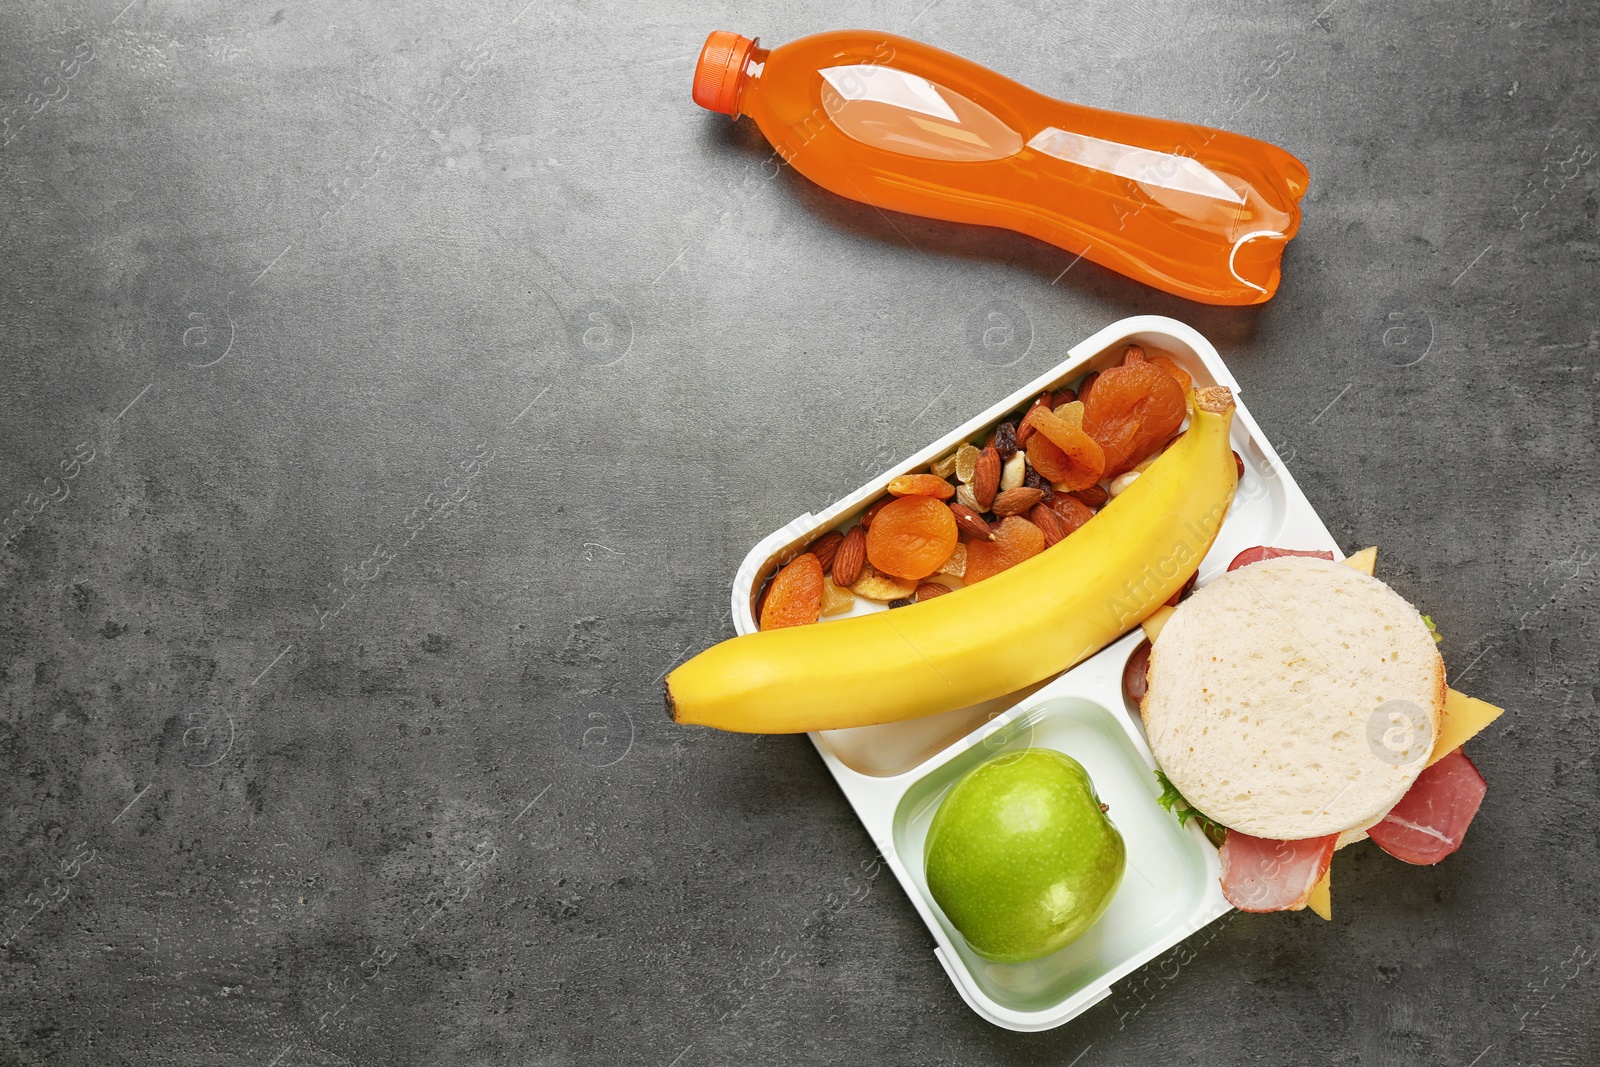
<box><xmin>694</xmin><ymin>30</ymin><xmax>1307</xmax><ymax>304</ymax></box>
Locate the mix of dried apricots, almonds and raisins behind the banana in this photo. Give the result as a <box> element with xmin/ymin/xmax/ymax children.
<box><xmin>757</xmin><ymin>344</ymin><xmax>1194</xmax><ymax>630</ymax></box>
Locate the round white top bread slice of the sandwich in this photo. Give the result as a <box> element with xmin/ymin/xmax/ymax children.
<box><xmin>1141</xmin><ymin>557</ymin><xmax>1445</xmax><ymax>841</ymax></box>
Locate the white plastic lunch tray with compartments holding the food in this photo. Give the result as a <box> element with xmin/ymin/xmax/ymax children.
<box><xmin>733</xmin><ymin>315</ymin><xmax>1342</xmax><ymax>1030</ymax></box>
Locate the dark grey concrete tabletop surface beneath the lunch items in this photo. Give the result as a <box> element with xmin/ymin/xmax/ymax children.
<box><xmin>0</xmin><ymin>0</ymin><xmax>1600</xmax><ymax>1067</ymax></box>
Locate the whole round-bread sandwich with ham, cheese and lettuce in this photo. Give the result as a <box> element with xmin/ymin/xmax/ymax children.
<box><xmin>1130</xmin><ymin>549</ymin><xmax>1501</xmax><ymax>918</ymax></box>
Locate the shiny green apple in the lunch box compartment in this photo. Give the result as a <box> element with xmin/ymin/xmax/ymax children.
<box><xmin>925</xmin><ymin>749</ymin><xmax>1126</xmax><ymax>963</ymax></box>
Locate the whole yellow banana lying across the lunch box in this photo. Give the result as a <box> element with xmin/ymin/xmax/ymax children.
<box><xmin>667</xmin><ymin>386</ymin><xmax>1238</xmax><ymax>734</ymax></box>
